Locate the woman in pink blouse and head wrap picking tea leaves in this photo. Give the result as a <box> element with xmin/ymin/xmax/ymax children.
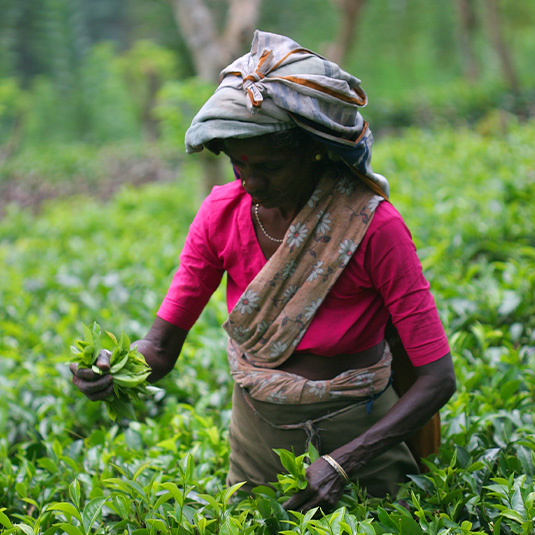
<box><xmin>72</xmin><ymin>31</ymin><xmax>455</xmax><ymax>510</ymax></box>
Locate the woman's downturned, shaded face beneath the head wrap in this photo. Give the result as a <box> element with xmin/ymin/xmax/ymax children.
<box><xmin>223</xmin><ymin>136</ymin><xmax>320</xmax><ymax>216</ymax></box>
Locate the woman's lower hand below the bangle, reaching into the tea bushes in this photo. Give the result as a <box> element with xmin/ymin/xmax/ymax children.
<box><xmin>283</xmin><ymin>458</ymin><xmax>345</xmax><ymax>512</ymax></box>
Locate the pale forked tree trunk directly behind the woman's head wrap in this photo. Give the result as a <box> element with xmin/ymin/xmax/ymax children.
<box><xmin>171</xmin><ymin>0</ymin><xmax>262</xmax><ymax>192</ymax></box>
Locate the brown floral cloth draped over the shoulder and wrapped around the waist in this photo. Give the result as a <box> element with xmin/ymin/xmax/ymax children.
<box><xmin>223</xmin><ymin>171</ymin><xmax>391</xmax><ymax>403</ymax></box>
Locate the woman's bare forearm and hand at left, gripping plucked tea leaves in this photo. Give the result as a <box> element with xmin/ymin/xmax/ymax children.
<box><xmin>70</xmin><ymin>317</ymin><xmax>188</xmax><ymax>401</ymax></box>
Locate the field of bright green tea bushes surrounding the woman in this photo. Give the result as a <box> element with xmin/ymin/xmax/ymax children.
<box><xmin>0</xmin><ymin>122</ymin><xmax>535</xmax><ymax>535</ymax></box>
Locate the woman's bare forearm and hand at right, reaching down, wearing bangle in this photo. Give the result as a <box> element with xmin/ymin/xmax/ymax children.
<box><xmin>284</xmin><ymin>353</ymin><xmax>456</xmax><ymax>510</ymax></box>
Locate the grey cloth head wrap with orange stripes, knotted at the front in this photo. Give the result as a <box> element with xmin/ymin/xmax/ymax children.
<box><xmin>186</xmin><ymin>30</ymin><xmax>389</xmax><ymax>196</ymax></box>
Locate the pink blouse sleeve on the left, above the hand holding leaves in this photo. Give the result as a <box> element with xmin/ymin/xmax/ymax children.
<box><xmin>157</xmin><ymin>197</ymin><xmax>224</xmax><ymax>330</ymax></box>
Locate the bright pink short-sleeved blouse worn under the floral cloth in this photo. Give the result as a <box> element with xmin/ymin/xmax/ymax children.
<box><xmin>158</xmin><ymin>180</ymin><xmax>449</xmax><ymax>366</ymax></box>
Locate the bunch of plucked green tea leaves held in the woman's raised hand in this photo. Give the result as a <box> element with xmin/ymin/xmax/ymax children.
<box><xmin>71</xmin><ymin>323</ymin><xmax>153</xmax><ymax>421</ymax></box>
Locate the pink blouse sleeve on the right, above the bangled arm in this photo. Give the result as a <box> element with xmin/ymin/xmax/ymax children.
<box><xmin>366</xmin><ymin>206</ymin><xmax>450</xmax><ymax>366</ymax></box>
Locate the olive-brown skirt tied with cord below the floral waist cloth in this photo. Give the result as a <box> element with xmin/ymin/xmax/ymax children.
<box><xmin>227</xmin><ymin>385</ymin><xmax>419</xmax><ymax>497</ymax></box>
